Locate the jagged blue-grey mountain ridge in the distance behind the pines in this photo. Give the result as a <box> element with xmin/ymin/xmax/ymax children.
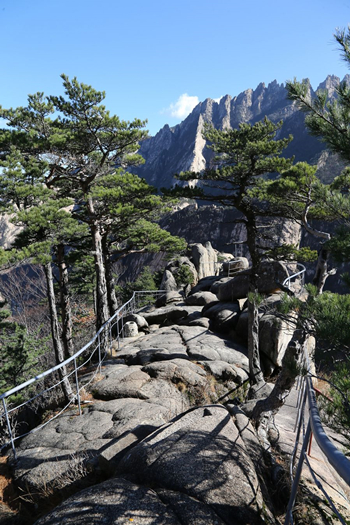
<box><xmin>136</xmin><ymin>75</ymin><xmax>350</xmax><ymax>188</ymax></box>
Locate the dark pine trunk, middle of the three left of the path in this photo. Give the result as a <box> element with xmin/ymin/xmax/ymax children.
<box><xmin>57</xmin><ymin>244</ymin><xmax>74</xmax><ymax>358</ymax></box>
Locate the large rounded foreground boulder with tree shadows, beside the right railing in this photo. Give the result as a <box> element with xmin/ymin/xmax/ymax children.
<box><xmin>117</xmin><ymin>405</ymin><xmax>265</xmax><ymax>525</ymax></box>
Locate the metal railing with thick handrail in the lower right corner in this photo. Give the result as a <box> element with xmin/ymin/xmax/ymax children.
<box><xmin>284</xmin><ymin>338</ymin><xmax>350</xmax><ymax>525</ymax></box>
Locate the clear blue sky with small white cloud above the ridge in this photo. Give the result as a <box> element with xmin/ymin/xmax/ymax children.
<box><xmin>0</xmin><ymin>0</ymin><xmax>350</xmax><ymax>134</ymax></box>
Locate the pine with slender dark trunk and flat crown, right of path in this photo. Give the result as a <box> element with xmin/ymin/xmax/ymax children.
<box><xmin>165</xmin><ymin>118</ymin><xmax>293</xmax><ymax>388</ymax></box>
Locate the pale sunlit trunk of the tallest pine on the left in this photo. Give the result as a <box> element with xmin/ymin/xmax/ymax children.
<box><xmin>87</xmin><ymin>199</ymin><xmax>110</xmax><ymax>330</ymax></box>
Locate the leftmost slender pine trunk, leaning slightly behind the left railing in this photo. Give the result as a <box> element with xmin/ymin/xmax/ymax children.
<box><xmin>44</xmin><ymin>263</ymin><xmax>73</xmax><ymax>403</ymax></box>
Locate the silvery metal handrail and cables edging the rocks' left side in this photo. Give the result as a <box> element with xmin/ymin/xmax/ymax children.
<box><xmin>0</xmin><ymin>290</ymin><xmax>165</xmax><ymax>458</ymax></box>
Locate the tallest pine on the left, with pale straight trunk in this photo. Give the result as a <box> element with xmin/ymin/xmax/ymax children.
<box><xmin>0</xmin><ymin>75</ymin><xmax>185</xmax><ymax>334</ymax></box>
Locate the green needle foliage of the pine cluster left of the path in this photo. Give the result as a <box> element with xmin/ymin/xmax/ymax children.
<box><xmin>0</xmin><ymin>75</ymin><xmax>185</xmax><ymax>336</ymax></box>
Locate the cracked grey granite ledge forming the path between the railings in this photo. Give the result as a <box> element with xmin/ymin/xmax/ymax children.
<box><xmin>5</xmin><ymin>264</ymin><xmax>302</xmax><ymax>525</ymax></box>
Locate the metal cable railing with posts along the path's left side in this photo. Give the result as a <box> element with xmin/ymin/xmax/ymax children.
<box><xmin>0</xmin><ymin>290</ymin><xmax>164</xmax><ymax>458</ymax></box>
